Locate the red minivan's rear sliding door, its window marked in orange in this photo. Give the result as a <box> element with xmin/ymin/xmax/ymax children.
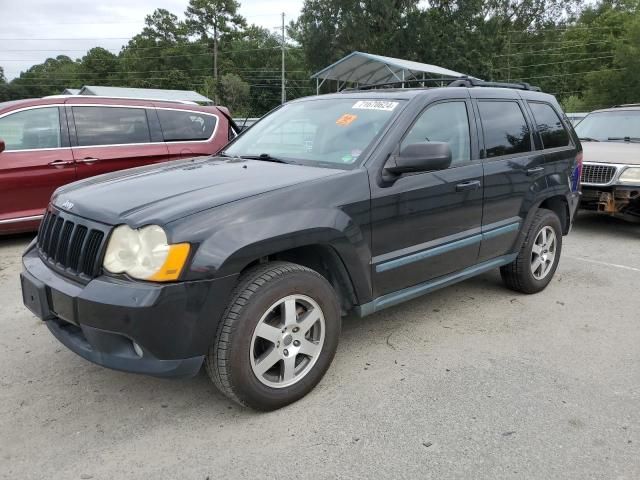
<box><xmin>67</xmin><ymin>105</ymin><xmax>168</xmax><ymax>178</ymax></box>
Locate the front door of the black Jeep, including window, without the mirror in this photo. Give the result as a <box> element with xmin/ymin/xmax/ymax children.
<box><xmin>371</xmin><ymin>98</ymin><xmax>482</xmax><ymax>297</ymax></box>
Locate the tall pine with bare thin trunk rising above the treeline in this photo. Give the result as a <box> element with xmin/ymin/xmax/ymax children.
<box><xmin>185</xmin><ymin>0</ymin><xmax>246</xmax><ymax>80</ymax></box>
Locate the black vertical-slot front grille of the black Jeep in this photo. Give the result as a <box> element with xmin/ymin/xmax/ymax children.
<box><xmin>38</xmin><ymin>211</ymin><xmax>107</xmax><ymax>278</ymax></box>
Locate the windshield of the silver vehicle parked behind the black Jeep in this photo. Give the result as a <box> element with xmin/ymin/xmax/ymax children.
<box><xmin>575</xmin><ymin>110</ymin><xmax>640</xmax><ymax>142</ymax></box>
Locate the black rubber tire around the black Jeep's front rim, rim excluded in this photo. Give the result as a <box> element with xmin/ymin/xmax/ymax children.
<box><xmin>205</xmin><ymin>262</ymin><xmax>341</xmax><ymax>411</ymax></box>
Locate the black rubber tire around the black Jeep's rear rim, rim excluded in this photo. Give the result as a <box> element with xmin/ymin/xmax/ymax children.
<box><xmin>500</xmin><ymin>208</ymin><xmax>562</xmax><ymax>294</ymax></box>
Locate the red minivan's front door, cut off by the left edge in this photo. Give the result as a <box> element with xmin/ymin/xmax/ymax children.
<box><xmin>0</xmin><ymin>105</ymin><xmax>76</xmax><ymax>225</ymax></box>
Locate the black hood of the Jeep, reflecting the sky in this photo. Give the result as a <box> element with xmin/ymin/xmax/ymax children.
<box><xmin>53</xmin><ymin>157</ymin><xmax>343</xmax><ymax>228</ymax></box>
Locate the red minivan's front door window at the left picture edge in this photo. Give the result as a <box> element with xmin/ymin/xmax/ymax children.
<box><xmin>0</xmin><ymin>107</ymin><xmax>61</xmax><ymax>150</ymax></box>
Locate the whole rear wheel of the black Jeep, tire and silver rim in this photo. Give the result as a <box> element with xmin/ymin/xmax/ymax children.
<box><xmin>500</xmin><ymin>208</ymin><xmax>562</xmax><ymax>293</ymax></box>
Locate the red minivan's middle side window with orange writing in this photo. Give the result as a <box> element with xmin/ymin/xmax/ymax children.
<box><xmin>73</xmin><ymin>107</ymin><xmax>151</xmax><ymax>147</ymax></box>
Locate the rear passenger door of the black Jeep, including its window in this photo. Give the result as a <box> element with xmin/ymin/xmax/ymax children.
<box><xmin>472</xmin><ymin>89</ymin><xmax>546</xmax><ymax>261</ymax></box>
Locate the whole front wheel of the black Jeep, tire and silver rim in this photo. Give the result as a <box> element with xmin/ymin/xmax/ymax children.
<box><xmin>206</xmin><ymin>262</ymin><xmax>341</xmax><ymax>410</ymax></box>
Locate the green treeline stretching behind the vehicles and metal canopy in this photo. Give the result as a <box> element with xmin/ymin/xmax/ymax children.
<box><xmin>0</xmin><ymin>0</ymin><xmax>640</xmax><ymax>116</ymax></box>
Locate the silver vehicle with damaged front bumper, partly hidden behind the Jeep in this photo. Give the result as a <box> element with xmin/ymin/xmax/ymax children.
<box><xmin>575</xmin><ymin>104</ymin><xmax>640</xmax><ymax>221</ymax></box>
